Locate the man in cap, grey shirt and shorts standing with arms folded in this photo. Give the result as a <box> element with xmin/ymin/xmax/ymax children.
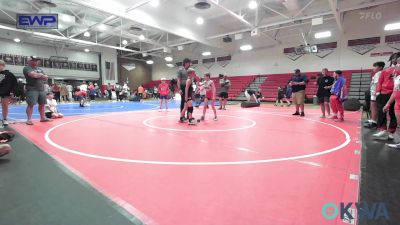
<box><xmin>23</xmin><ymin>56</ymin><xmax>50</xmax><ymax>125</ymax></box>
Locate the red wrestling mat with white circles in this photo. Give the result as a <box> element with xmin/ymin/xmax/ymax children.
<box><xmin>13</xmin><ymin>106</ymin><xmax>361</xmax><ymax>225</ymax></box>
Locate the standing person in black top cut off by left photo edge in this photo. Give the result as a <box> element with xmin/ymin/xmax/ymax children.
<box><xmin>0</xmin><ymin>60</ymin><xmax>17</xmax><ymax>126</ymax></box>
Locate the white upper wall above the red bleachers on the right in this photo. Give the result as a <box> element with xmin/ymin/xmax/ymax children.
<box><xmin>152</xmin><ymin>3</ymin><xmax>400</xmax><ymax>80</ymax></box>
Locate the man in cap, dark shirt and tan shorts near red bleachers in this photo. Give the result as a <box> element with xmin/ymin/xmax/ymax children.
<box><xmin>290</xmin><ymin>69</ymin><xmax>308</xmax><ymax>116</ymax></box>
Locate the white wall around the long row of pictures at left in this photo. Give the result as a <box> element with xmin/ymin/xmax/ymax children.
<box><xmin>0</xmin><ymin>39</ymin><xmax>100</xmax><ymax>80</ymax></box>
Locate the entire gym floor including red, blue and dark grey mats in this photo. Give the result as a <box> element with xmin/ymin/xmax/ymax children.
<box><xmin>0</xmin><ymin>101</ymin><xmax>399</xmax><ymax>225</ymax></box>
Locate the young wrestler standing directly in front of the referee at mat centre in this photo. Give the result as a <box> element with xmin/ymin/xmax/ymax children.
<box><xmin>180</xmin><ymin>68</ymin><xmax>196</xmax><ymax>125</ymax></box>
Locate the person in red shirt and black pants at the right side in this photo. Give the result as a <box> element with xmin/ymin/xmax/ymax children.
<box><xmin>372</xmin><ymin>52</ymin><xmax>400</xmax><ymax>140</ymax></box>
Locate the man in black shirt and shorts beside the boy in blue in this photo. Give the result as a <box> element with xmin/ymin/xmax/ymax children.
<box><xmin>317</xmin><ymin>68</ymin><xmax>335</xmax><ymax>118</ymax></box>
